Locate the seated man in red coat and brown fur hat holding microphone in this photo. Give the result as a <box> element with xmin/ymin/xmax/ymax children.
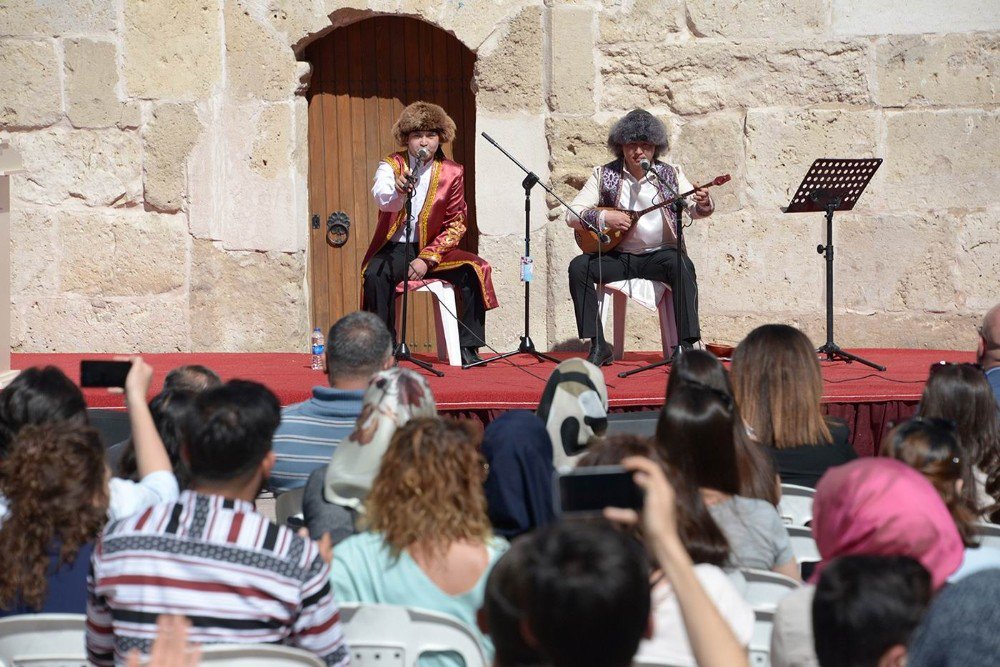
<box><xmin>361</xmin><ymin>102</ymin><xmax>497</xmax><ymax>364</ymax></box>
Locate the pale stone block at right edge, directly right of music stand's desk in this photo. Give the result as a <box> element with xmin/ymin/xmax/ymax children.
<box><xmin>876</xmin><ymin>110</ymin><xmax>1000</xmax><ymax>210</ymax></box>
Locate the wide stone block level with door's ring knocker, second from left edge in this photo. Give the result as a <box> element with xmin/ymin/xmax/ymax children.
<box><xmin>59</xmin><ymin>211</ymin><xmax>188</xmax><ymax>297</ymax></box>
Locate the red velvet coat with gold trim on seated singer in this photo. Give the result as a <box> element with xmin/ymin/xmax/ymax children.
<box><xmin>361</xmin><ymin>152</ymin><xmax>499</xmax><ymax>310</ymax></box>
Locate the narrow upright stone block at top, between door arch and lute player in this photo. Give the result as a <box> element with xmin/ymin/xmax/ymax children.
<box><xmin>549</xmin><ymin>5</ymin><xmax>596</xmax><ymax>116</ymax></box>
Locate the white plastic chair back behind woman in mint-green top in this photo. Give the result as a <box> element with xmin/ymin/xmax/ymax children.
<box><xmin>340</xmin><ymin>604</ymin><xmax>487</xmax><ymax>667</ymax></box>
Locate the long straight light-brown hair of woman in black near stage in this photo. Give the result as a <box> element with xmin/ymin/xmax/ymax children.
<box><xmin>730</xmin><ymin>324</ymin><xmax>833</xmax><ymax>449</ymax></box>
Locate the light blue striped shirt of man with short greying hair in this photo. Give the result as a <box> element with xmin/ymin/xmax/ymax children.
<box><xmin>269</xmin><ymin>387</ymin><xmax>365</xmax><ymax>493</ymax></box>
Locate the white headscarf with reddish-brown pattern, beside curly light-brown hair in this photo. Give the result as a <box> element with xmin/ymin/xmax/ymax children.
<box><xmin>323</xmin><ymin>368</ymin><xmax>437</xmax><ymax>511</ymax></box>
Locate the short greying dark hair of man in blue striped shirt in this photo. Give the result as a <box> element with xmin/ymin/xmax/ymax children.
<box><xmin>326</xmin><ymin>311</ymin><xmax>392</xmax><ymax>384</ymax></box>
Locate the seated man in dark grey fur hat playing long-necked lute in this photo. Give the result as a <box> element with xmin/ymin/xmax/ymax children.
<box><xmin>566</xmin><ymin>109</ymin><xmax>715</xmax><ymax>366</ymax></box>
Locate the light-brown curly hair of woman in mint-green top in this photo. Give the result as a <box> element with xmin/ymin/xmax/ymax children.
<box><xmin>363</xmin><ymin>417</ymin><xmax>492</xmax><ymax>558</ymax></box>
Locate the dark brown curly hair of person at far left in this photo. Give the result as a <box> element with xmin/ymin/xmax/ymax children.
<box><xmin>0</xmin><ymin>422</ymin><xmax>108</xmax><ymax>609</ymax></box>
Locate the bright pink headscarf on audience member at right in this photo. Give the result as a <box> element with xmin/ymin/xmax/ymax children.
<box><xmin>811</xmin><ymin>458</ymin><xmax>964</xmax><ymax>590</ymax></box>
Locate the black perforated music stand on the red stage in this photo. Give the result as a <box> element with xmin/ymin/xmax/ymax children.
<box><xmin>781</xmin><ymin>158</ymin><xmax>885</xmax><ymax>371</ymax></box>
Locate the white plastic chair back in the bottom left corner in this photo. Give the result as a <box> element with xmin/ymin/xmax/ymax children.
<box><xmin>0</xmin><ymin>614</ymin><xmax>87</xmax><ymax>667</ymax></box>
